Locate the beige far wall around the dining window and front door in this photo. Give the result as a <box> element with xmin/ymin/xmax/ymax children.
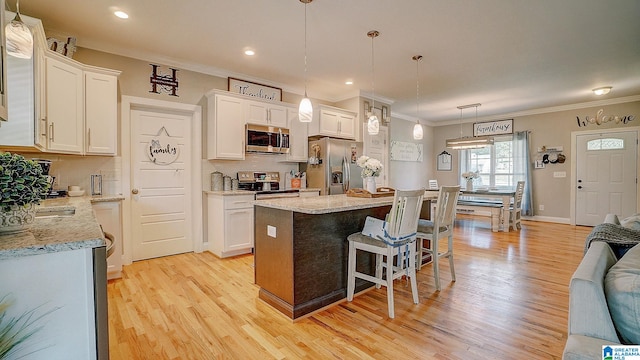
<box><xmin>431</xmin><ymin>101</ymin><xmax>640</xmax><ymax>220</ymax></box>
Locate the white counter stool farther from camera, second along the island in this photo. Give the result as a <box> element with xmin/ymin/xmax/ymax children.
<box><xmin>416</xmin><ymin>185</ymin><xmax>460</xmax><ymax>291</ymax></box>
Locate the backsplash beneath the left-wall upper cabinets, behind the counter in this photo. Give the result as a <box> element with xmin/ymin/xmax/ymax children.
<box><xmin>23</xmin><ymin>154</ymin><xmax>122</xmax><ymax>195</ymax></box>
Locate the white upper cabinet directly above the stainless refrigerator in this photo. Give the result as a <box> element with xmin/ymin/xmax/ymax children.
<box><xmin>309</xmin><ymin>105</ymin><xmax>356</xmax><ymax>139</ymax></box>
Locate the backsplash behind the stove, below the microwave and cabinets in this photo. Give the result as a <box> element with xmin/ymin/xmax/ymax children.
<box><xmin>202</xmin><ymin>153</ymin><xmax>299</xmax><ymax>190</ymax></box>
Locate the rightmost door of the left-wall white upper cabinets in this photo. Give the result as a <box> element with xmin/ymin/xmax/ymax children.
<box><xmin>84</xmin><ymin>71</ymin><xmax>118</xmax><ymax>155</ymax></box>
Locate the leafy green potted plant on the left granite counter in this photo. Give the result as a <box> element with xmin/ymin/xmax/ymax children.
<box><xmin>0</xmin><ymin>152</ymin><xmax>49</xmax><ymax>233</ymax></box>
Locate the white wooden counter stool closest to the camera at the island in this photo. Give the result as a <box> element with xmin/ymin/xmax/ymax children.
<box><xmin>347</xmin><ymin>189</ymin><xmax>424</xmax><ymax>318</ymax></box>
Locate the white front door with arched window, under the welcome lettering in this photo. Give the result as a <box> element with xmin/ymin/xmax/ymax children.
<box><xmin>575</xmin><ymin>131</ymin><xmax>638</xmax><ymax>226</ymax></box>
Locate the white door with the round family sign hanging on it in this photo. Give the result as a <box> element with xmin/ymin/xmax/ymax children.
<box><xmin>131</xmin><ymin>109</ymin><xmax>194</xmax><ymax>261</ymax></box>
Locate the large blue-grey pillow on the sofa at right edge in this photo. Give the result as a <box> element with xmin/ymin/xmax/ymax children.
<box><xmin>604</xmin><ymin>244</ymin><xmax>640</xmax><ymax>344</ymax></box>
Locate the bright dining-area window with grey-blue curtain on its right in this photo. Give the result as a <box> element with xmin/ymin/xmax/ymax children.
<box><xmin>458</xmin><ymin>131</ymin><xmax>533</xmax><ymax>216</ymax></box>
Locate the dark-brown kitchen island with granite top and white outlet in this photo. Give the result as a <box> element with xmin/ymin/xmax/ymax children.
<box><xmin>254</xmin><ymin>195</ymin><xmax>430</xmax><ymax>320</ymax></box>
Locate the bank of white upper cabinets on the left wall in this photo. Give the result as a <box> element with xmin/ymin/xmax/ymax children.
<box><xmin>0</xmin><ymin>12</ymin><xmax>120</xmax><ymax>155</ymax></box>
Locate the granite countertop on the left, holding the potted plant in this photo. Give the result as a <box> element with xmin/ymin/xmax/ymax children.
<box><xmin>0</xmin><ymin>195</ymin><xmax>124</xmax><ymax>260</ymax></box>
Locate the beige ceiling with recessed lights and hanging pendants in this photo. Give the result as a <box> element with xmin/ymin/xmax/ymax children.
<box><xmin>15</xmin><ymin>0</ymin><xmax>640</xmax><ymax>124</ymax></box>
